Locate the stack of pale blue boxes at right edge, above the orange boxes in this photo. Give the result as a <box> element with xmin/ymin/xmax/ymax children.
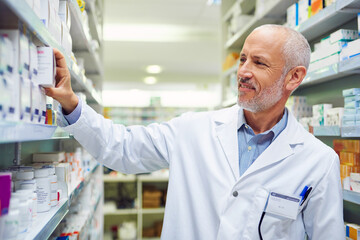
<box><xmin>342</xmin><ymin>88</ymin><xmax>360</xmax><ymax>126</ymax></box>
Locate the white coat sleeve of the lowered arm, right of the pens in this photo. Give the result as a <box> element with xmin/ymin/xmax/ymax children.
<box><xmin>303</xmin><ymin>154</ymin><xmax>345</xmax><ymax>240</ymax></box>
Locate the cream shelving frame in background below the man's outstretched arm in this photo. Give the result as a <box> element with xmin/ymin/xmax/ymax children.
<box><xmin>103</xmin><ymin>175</ymin><xmax>169</xmax><ymax>239</ymax></box>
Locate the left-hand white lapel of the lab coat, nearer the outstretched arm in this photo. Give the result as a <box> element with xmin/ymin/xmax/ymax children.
<box><xmin>214</xmin><ymin>106</ymin><xmax>240</xmax><ymax>180</ymax></box>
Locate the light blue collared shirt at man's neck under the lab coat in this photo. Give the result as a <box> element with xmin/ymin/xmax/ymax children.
<box><xmin>238</xmin><ymin>109</ymin><xmax>288</xmax><ymax>176</ymax></box>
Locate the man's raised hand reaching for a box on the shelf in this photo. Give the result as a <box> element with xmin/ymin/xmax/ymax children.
<box><xmin>45</xmin><ymin>48</ymin><xmax>79</xmax><ymax>114</ymax></box>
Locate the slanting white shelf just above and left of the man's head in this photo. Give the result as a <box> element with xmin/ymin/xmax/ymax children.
<box><xmin>225</xmin><ymin>0</ymin><xmax>292</xmax><ymax>49</ymax></box>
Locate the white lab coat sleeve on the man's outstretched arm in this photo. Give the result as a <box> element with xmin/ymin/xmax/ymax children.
<box><xmin>58</xmin><ymin>104</ymin><xmax>177</xmax><ymax>173</ymax></box>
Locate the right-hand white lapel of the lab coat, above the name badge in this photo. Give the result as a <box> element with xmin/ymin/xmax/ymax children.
<box><xmin>241</xmin><ymin>109</ymin><xmax>304</xmax><ymax>178</ymax></box>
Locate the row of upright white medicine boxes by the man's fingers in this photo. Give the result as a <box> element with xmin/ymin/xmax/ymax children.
<box><xmin>0</xmin><ymin>30</ymin><xmax>56</xmax><ymax>123</ymax></box>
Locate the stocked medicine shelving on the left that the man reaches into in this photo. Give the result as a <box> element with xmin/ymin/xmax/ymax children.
<box><xmin>0</xmin><ymin>0</ymin><xmax>103</xmax><ymax>239</ymax></box>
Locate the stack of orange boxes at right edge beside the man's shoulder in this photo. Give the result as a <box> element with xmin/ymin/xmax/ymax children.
<box><xmin>333</xmin><ymin>139</ymin><xmax>360</xmax><ymax>184</ymax></box>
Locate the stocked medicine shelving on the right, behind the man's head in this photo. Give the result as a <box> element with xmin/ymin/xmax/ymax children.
<box><xmin>222</xmin><ymin>0</ymin><xmax>360</xmax><ymax>239</ymax></box>
